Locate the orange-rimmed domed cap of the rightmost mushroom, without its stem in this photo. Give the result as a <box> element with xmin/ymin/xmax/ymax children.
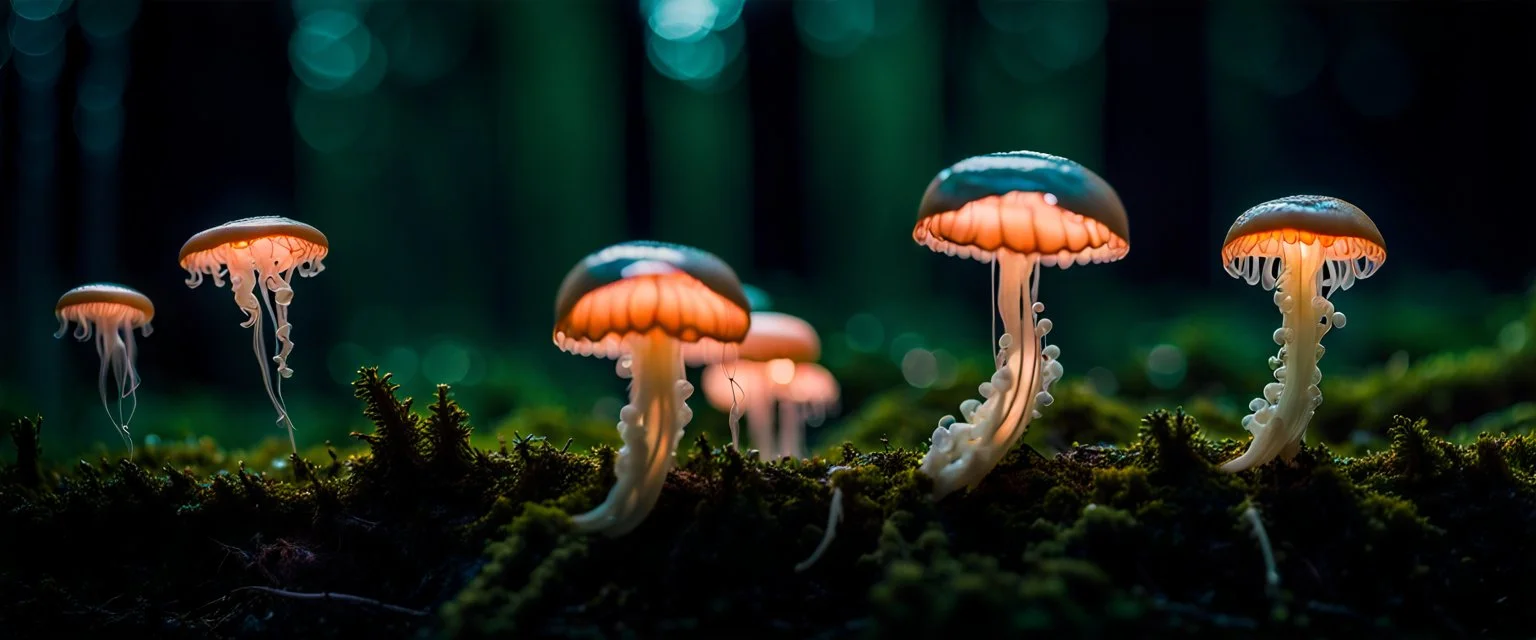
<box><xmin>1221</xmin><ymin>195</ymin><xmax>1387</xmax><ymax>267</ymax></box>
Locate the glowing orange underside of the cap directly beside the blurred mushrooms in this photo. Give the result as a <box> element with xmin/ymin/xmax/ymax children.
<box><xmin>554</xmin><ymin>273</ymin><xmax>750</xmax><ymax>342</ymax></box>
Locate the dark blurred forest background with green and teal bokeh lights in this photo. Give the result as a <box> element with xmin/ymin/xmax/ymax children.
<box><xmin>0</xmin><ymin>0</ymin><xmax>1536</xmax><ymax>442</ymax></box>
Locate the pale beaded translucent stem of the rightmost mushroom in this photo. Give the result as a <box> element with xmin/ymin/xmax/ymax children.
<box><xmin>1221</xmin><ymin>242</ymin><xmax>1350</xmax><ymax>471</ymax></box>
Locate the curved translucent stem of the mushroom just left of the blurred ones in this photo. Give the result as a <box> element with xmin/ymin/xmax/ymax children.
<box><xmin>571</xmin><ymin>332</ymin><xmax>693</xmax><ymax>536</ymax></box>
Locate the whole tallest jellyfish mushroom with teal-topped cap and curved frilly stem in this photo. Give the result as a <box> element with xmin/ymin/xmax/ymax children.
<box><xmin>912</xmin><ymin>150</ymin><xmax>1130</xmax><ymax>499</ymax></box>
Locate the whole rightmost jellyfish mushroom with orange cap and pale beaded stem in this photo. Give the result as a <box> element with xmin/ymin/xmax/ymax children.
<box><xmin>1221</xmin><ymin>195</ymin><xmax>1387</xmax><ymax>471</ymax></box>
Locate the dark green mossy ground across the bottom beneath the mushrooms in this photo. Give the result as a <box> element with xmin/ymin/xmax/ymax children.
<box><xmin>0</xmin><ymin>370</ymin><xmax>1536</xmax><ymax>638</ymax></box>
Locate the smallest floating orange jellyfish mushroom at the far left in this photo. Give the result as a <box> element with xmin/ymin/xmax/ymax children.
<box><xmin>54</xmin><ymin>282</ymin><xmax>155</xmax><ymax>456</ymax></box>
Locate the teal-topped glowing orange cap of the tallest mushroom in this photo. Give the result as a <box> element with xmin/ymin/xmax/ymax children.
<box><xmin>912</xmin><ymin>150</ymin><xmax>1130</xmax><ymax>267</ymax></box>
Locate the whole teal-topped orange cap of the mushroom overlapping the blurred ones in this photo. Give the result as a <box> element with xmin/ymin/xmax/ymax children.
<box><xmin>554</xmin><ymin>241</ymin><xmax>751</xmax><ymax>358</ymax></box>
